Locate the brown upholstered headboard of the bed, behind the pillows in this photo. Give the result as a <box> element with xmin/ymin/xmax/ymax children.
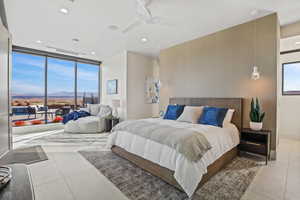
<box><xmin>169</xmin><ymin>97</ymin><xmax>243</xmax><ymax>131</ymax></box>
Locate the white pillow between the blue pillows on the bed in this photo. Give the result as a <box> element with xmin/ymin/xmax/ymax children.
<box><xmin>177</xmin><ymin>106</ymin><xmax>204</xmax><ymax>124</ymax></box>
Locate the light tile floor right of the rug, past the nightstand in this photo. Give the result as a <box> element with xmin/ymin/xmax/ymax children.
<box><xmin>242</xmin><ymin>138</ymin><xmax>300</xmax><ymax>200</ymax></box>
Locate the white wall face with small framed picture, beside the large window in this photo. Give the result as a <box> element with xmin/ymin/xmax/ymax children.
<box><xmin>101</xmin><ymin>51</ymin><xmax>127</xmax><ymax>120</ymax></box>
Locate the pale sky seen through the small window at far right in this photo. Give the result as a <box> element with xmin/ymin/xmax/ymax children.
<box><xmin>283</xmin><ymin>63</ymin><xmax>300</xmax><ymax>91</ymax></box>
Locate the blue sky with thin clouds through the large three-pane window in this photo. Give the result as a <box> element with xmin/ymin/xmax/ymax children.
<box><xmin>12</xmin><ymin>52</ymin><xmax>99</xmax><ymax>96</ymax></box>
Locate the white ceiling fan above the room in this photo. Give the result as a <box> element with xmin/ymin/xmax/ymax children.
<box><xmin>122</xmin><ymin>0</ymin><xmax>170</xmax><ymax>34</ymax></box>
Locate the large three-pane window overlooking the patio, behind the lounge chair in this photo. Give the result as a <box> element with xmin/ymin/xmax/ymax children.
<box><xmin>12</xmin><ymin>48</ymin><xmax>100</xmax><ymax>126</ymax></box>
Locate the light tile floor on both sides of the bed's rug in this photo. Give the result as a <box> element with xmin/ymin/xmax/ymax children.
<box><xmin>24</xmin><ymin>136</ymin><xmax>300</xmax><ymax>200</ymax></box>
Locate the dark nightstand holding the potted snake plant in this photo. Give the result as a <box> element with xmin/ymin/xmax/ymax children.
<box><xmin>239</xmin><ymin>128</ymin><xmax>271</xmax><ymax>165</ymax></box>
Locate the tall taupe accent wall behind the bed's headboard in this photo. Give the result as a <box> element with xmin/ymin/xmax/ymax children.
<box><xmin>159</xmin><ymin>14</ymin><xmax>280</xmax><ymax>153</ymax></box>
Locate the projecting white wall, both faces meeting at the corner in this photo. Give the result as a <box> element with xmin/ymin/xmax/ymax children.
<box><xmin>101</xmin><ymin>51</ymin><xmax>159</xmax><ymax>120</ymax></box>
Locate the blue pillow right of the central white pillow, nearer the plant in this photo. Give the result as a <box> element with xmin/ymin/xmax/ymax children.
<box><xmin>198</xmin><ymin>107</ymin><xmax>228</xmax><ymax>127</ymax></box>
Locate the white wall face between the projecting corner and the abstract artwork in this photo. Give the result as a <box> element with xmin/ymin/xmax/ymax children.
<box><xmin>127</xmin><ymin>52</ymin><xmax>158</xmax><ymax>119</ymax></box>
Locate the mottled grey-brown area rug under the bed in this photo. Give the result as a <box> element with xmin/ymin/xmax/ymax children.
<box><xmin>79</xmin><ymin>151</ymin><xmax>260</xmax><ymax>200</ymax></box>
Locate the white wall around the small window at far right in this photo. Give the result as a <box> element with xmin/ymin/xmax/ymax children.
<box><xmin>277</xmin><ymin>37</ymin><xmax>300</xmax><ymax>139</ymax></box>
